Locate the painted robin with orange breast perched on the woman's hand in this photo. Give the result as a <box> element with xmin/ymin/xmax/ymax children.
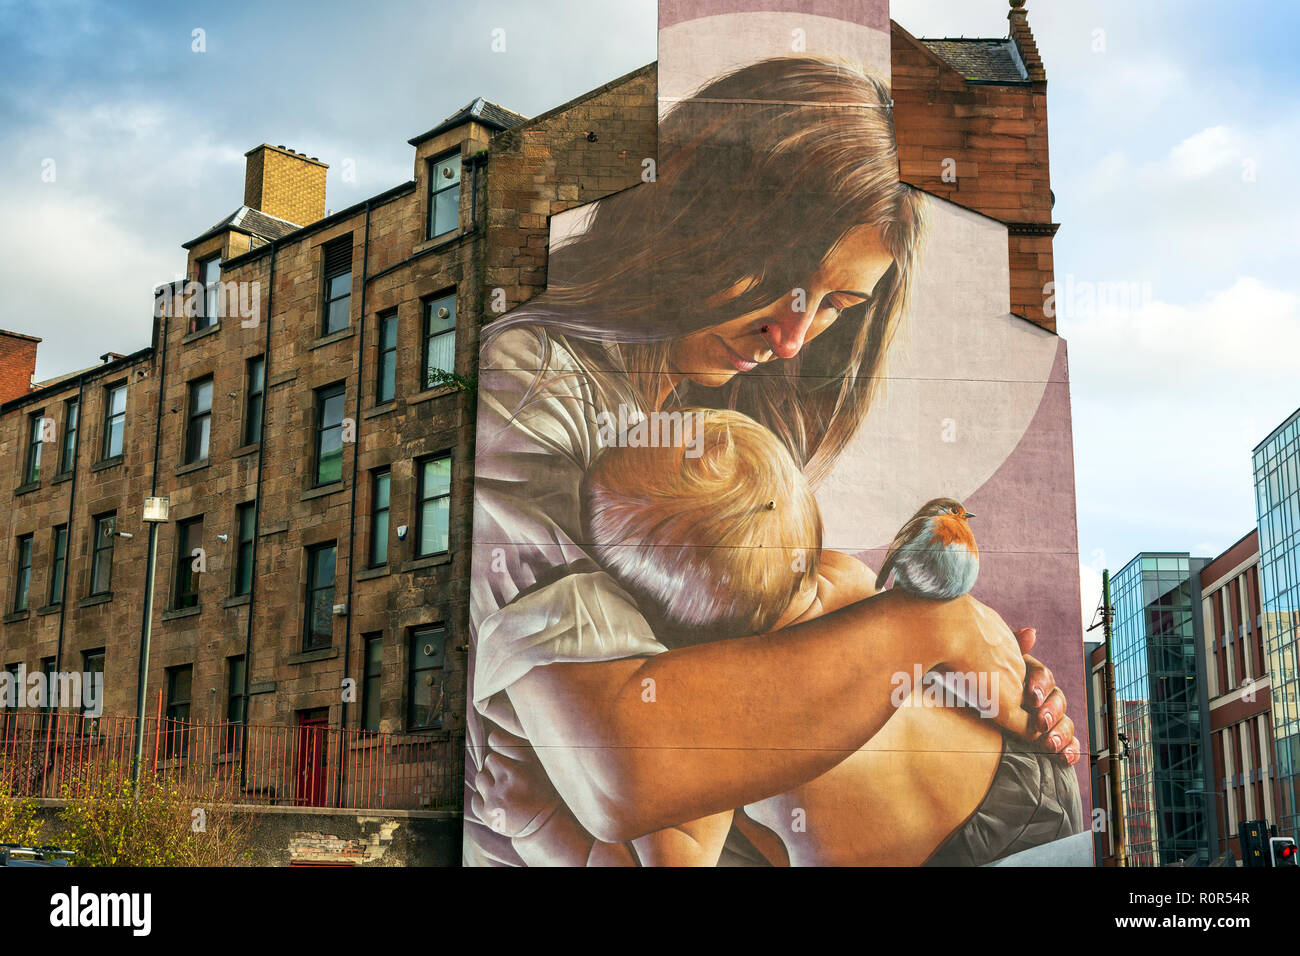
<box><xmin>876</xmin><ymin>498</ymin><xmax>979</xmax><ymax>601</ymax></box>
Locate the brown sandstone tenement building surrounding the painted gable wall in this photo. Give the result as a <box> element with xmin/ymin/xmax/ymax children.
<box><xmin>0</xmin><ymin>3</ymin><xmax>1056</xmax><ymax>811</ymax></box>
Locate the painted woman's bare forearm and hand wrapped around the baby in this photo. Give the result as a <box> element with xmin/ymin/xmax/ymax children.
<box><xmin>508</xmin><ymin>592</ymin><xmax>1034</xmax><ymax>843</ymax></box>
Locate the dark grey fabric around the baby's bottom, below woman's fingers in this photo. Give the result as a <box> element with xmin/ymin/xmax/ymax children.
<box><xmin>926</xmin><ymin>739</ymin><xmax>1083</xmax><ymax>866</ymax></box>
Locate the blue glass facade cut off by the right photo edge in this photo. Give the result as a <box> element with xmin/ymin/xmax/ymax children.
<box><xmin>1255</xmin><ymin>412</ymin><xmax>1300</xmax><ymax>835</ymax></box>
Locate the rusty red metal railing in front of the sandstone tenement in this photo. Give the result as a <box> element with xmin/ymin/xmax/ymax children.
<box><xmin>0</xmin><ymin>710</ymin><xmax>464</xmax><ymax>810</ymax></box>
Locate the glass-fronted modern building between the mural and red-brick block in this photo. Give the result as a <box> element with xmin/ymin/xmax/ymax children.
<box><xmin>1110</xmin><ymin>553</ymin><xmax>1216</xmax><ymax>866</ymax></box>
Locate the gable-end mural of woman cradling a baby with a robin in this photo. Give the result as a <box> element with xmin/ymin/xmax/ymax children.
<box><xmin>464</xmin><ymin>0</ymin><xmax>1092</xmax><ymax>866</ymax></box>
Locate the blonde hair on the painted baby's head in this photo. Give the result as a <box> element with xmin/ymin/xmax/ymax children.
<box><xmin>581</xmin><ymin>408</ymin><xmax>822</xmax><ymax>636</ymax></box>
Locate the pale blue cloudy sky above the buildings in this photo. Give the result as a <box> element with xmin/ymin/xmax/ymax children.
<box><xmin>0</xmin><ymin>0</ymin><xmax>1300</xmax><ymax>634</ymax></box>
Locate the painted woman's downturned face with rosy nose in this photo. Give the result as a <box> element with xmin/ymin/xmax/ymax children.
<box><xmin>668</xmin><ymin>226</ymin><xmax>893</xmax><ymax>388</ymax></box>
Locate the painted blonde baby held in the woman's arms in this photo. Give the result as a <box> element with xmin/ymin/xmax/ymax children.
<box><xmin>493</xmin><ymin>410</ymin><xmax>1082</xmax><ymax>866</ymax></box>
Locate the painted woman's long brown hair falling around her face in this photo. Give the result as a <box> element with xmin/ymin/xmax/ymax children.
<box><xmin>485</xmin><ymin>57</ymin><xmax>924</xmax><ymax>483</ymax></box>
